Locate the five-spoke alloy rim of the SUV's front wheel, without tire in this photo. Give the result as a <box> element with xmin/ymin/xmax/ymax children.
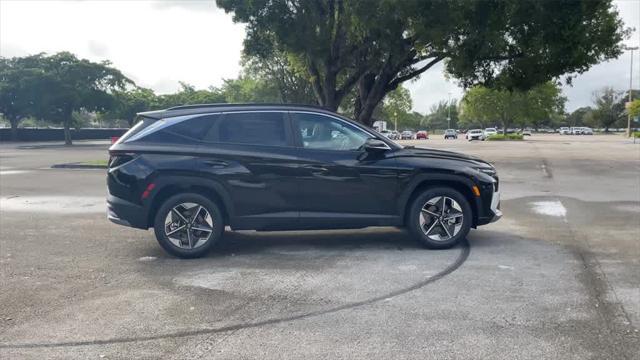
<box><xmin>420</xmin><ymin>196</ymin><xmax>464</xmax><ymax>241</ymax></box>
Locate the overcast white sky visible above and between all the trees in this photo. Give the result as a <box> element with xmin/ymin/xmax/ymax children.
<box><xmin>0</xmin><ymin>0</ymin><xmax>640</xmax><ymax>112</ymax></box>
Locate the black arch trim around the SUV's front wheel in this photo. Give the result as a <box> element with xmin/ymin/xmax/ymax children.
<box><xmin>400</xmin><ymin>174</ymin><xmax>481</xmax><ymax>228</ymax></box>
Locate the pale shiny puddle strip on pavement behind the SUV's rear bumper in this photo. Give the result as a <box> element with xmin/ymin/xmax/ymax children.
<box><xmin>0</xmin><ymin>195</ymin><xmax>107</xmax><ymax>214</ymax></box>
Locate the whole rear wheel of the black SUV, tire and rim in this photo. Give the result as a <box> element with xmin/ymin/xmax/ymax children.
<box><xmin>153</xmin><ymin>193</ymin><xmax>224</xmax><ymax>259</ymax></box>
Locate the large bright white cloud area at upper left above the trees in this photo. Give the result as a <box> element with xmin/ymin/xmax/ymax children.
<box><xmin>0</xmin><ymin>1</ymin><xmax>244</xmax><ymax>92</ymax></box>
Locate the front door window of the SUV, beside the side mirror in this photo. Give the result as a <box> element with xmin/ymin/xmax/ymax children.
<box><xmin>292</xmin><ymin>113</ymin><xmax>372</xmax><ymax>151</ymax></box>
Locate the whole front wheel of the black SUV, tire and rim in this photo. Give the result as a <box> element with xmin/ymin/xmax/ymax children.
<box><xmin>407</xmin><ymin>187</ymin><xmax>473</xmax><ymax>249</ymax></box>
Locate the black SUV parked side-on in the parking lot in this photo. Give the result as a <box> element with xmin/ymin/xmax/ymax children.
<box><xmin>107</xmin><ymin>104</ymin><xmax>502</xmax><ymax>257</ymax></box>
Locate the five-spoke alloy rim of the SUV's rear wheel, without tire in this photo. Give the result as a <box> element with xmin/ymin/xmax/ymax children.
<box><xmin>164</xmin><ymin>202</ymin><xmax>213</xmax><ymax>249</ymax></box>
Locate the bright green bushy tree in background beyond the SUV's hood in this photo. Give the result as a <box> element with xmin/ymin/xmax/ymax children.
<box><xmin>461</xmin><ymin>83</ymin><xmax>566</xmax><ymax>132</ymax></box>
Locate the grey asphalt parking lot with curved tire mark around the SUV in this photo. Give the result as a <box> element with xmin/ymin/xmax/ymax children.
<box><xmin>0</xmin><ymin>135</ymin><xmax>640</xmax><ymax>359</ymax></box>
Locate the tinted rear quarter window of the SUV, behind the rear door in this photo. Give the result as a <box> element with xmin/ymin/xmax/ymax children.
<box><xmin>142</xmin><ymin>114</ymin><xmax>219</xmax><ymax>144</ymax></box>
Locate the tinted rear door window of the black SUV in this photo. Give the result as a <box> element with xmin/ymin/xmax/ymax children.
<box><xmin>217</xmin><ymin>112</ymin><xmax>287</xmax><ymax>146</ymax></box>
